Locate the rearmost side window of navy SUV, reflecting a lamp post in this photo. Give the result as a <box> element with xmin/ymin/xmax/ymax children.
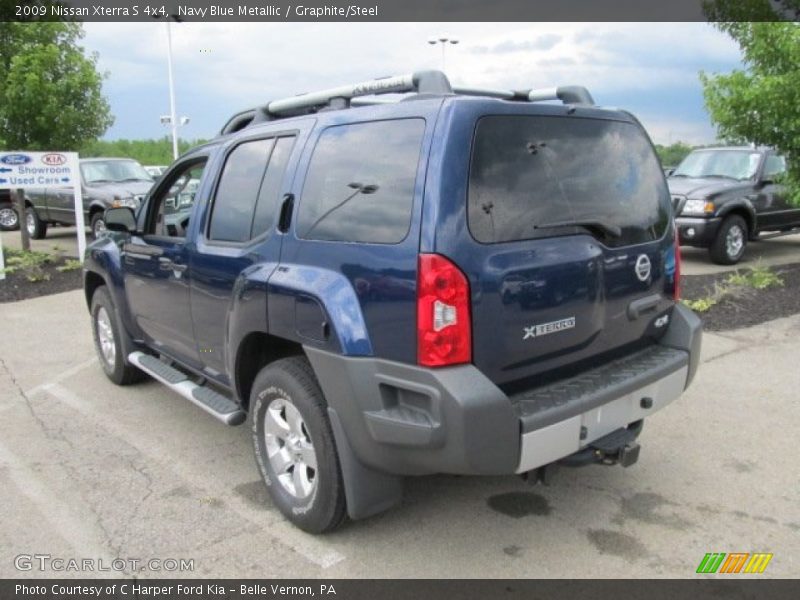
<box><xmin>297</xmin><ymin>119</ymin><xmax>425</xmax><ymax>244</ymax></box>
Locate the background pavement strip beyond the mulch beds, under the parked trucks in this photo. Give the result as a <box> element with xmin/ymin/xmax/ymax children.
<box><xmin>2</xmin><ymin>227</ymin><xmax>800</xmax><ymax>275</ymax></box>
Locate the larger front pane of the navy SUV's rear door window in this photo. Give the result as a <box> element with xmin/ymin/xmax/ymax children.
<box><xmin>208</xmin><ymin>139</ymin><xmax>275</xmax><ymax>242</ymax></box>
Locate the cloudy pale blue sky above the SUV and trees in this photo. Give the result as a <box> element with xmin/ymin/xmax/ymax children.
<box><xmin>83</xmin><ymin>23</ymin><xmax>741</xmax><ymax>144</ymax></box>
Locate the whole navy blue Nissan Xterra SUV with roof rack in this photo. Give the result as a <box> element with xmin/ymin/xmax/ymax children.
<box><xmin>85</xmin><ymin>71</ymin><xmax>701</xmax><ymax>533</ymax></box>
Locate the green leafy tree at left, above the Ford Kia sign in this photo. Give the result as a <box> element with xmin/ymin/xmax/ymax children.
<box><xmin>0</xmin><ymin>22</ymin><xmax>114</xmax><ymax>150</ymax></box>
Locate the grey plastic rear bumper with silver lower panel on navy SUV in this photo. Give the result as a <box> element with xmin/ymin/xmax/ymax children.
<box><xmin>306</xmin><ymin>305</ymin><xmax>702</xmax><ymax>475</ymax></box>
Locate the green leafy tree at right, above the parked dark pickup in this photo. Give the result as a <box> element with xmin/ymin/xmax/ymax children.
<box><xmin>700</xmin><ymin>0</ymin><xmax>800</xmax><ymax>205</ymax></box>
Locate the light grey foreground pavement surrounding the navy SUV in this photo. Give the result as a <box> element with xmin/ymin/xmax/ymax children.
<box><xmin>0</xmin><ymin>291</ymin><xmax>800</xmax><ymax>578</ymax></box>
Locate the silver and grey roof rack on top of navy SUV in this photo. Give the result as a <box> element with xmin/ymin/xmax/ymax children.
<box><xmin>220</xmin><ymin>71</ymin><xmax>594</xmax><ymax>135</ymax></box>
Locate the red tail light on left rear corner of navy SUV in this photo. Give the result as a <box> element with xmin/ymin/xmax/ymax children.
<box><xmin>417</xmin><ymin>254</ymin><xmax>472</xmax><ymax>367</ymax></box>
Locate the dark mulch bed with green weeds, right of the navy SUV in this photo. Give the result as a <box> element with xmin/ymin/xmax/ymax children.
<box><xmin>681</xmin><ymin>264</ymin><xmax>800</xmax><ymax>331</ymax></box>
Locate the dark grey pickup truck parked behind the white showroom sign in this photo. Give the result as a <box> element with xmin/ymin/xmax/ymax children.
<box><xmin>22</xmin><ymin>158</ymin><xmax>153</xmax><ymax>239</ymax></box>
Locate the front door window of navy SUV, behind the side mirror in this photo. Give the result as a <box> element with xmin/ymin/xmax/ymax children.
<box><xmin>148</xmin><ymin>159</ymin><xmax>206</xmax><ymax>238</ymax></box>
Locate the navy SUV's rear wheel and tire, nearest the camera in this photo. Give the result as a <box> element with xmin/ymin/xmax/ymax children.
<box><xmin>250</xmin><ymin>356</ymin><xmax>346</xmax><ymax>533</ymax></box>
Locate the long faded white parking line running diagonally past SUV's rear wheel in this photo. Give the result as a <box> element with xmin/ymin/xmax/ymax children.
<box><xmin>40</xmin><ymin>383</ymin><xmax>346</xmax><ymax>569</ymax></box>
